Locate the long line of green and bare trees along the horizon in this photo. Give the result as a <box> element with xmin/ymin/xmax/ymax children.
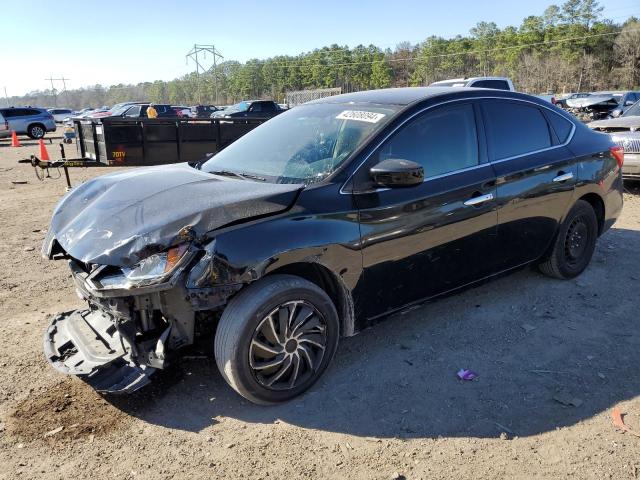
<box><xmin>8</xmin><ymin>0</ymin><xmax>640</xmax><ymax>109</ymax></box>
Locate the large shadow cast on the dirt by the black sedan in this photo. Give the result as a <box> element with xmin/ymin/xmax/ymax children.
<box><xmin>109</xmin><ymin>229</ymin><xmax>640</xmax><ymax>438</ymax></box>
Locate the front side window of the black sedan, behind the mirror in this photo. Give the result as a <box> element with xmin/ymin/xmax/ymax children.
<box><xmin>378</xmin><ymin>104</ymin><xmax>479</xmax><ymax>178</ymax></box>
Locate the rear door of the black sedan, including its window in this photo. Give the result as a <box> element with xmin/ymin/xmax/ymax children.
<box><xmin>482</xmin><ymin>99</ymin><xmax>577</xmax><ymax>268</ymax></box>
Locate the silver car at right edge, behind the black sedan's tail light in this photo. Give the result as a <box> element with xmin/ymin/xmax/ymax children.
<box><xmin>587</xmin><ymin>100</ymin><xmax>640</xmax><ymax>180</ymax></box>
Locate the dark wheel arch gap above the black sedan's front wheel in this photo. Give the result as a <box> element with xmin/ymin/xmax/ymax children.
<box><xmin>263</xmin><ymin>262</ymin><xmax>355</xmax><ymax>337</ymax></box>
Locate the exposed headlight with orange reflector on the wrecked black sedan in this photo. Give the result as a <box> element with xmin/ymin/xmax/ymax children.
<box><xmin>88</xmin><ymin>243</ymin><xmax>189</xmax><ymax>290</ymax></box>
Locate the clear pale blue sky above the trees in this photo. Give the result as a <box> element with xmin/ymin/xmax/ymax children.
<box><xmin>0</xmin><ymin>0</ymin><xmax>640</xmax><ymax>96</ymax></box>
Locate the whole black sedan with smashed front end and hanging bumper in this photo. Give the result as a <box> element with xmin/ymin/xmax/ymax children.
<box><xmin>42</xmin><ymin>88</ymin><xmax>623</xmax><ymax>404</ymax></box>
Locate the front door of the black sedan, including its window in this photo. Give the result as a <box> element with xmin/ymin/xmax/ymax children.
<box><xmin>354</xmin><ymin>101</ymin><xmax>497</xmax><ymax>317</ymax></box>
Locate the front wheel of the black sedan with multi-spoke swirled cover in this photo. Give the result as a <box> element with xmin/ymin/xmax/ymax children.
<box><xmin>215</xmin><ymin>275</ymin><xmax>339</xmax><ymax>405</ymax></box>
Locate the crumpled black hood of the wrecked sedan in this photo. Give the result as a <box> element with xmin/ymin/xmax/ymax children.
<box><xmin>43</xmin><ymin>163</ymin><xmax>302</xmax><ymax>266</ymax></box>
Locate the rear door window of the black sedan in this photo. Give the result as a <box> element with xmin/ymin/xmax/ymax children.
<box><xmin>482</xmin><ymin>101</ymin><xmax>551</xmax><ymax>160</ymax></box>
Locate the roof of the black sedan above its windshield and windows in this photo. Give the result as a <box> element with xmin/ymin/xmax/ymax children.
<box><xmin>306</xmin><ymin>87</ymin><xmax>528</xmax><ymax>106</ymax></box>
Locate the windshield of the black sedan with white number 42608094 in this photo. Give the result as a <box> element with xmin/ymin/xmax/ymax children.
<box><xmin>202</xmin><ymin>104</ymin><xmax>397</xmax><ymax>185</ymax></box>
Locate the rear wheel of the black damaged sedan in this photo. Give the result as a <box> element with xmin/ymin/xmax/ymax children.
<box><xmin>539</xmin><ymin>200</ymin><xmax>598</xmax><ymax>279</ymax></box>
